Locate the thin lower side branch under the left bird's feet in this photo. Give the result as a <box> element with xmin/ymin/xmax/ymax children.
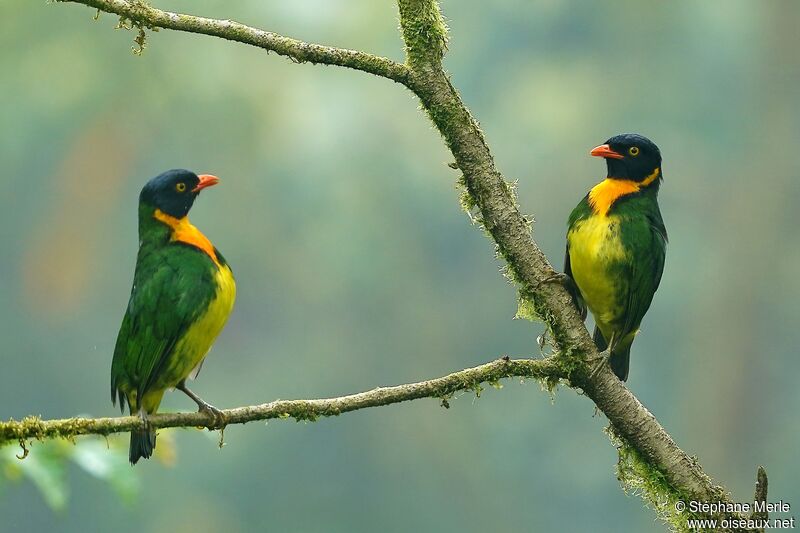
<box><xmin>0</xmin><ymin>357</ymin><xmax>562</xmax><ymax>446</ymax></box>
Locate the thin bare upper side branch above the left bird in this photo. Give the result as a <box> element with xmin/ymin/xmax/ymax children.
<box><xmin>57</xmin><ymin>0</ymin><xmax>409</xmax><ymax>84</ymax></box>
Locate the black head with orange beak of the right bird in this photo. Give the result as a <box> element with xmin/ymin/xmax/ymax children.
<box><xmin>589</xmin><ymin>133</ymin><xmax>663</xmax><ymax>185</ymax></box>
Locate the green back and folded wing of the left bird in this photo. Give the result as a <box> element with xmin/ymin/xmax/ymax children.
<box><xmin>111</xmin><ymin>243</ymin><xmax>216</xmax><ymax>412</ymax></box>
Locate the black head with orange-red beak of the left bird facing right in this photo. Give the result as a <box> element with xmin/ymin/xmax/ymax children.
<box><xmin>139</xmin><ymin>169</ymin><xmax>219</xmax><ymax>218</ymax></box>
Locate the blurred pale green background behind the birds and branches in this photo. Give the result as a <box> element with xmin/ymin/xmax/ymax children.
<box><xmin>0</xmin><ymin>0</ymin><xmax>800</xmax><ymax>533</ymax></box>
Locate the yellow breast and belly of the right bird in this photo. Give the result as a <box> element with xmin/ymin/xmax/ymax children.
<box><xmin>567</xmin><ymin>215</ymin><xmax>627</xmax><ymax>329</ymax></box>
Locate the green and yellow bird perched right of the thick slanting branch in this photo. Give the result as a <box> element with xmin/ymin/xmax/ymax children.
<box><xmin>564</xmin><ymin>133</ymin><xmax>667</xmax><ymax>381</ymax></box>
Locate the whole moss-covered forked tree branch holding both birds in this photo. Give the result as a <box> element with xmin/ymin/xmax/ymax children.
<box><xmin>31</xmin><ymin>0</ymin><xmax>766</xmax><ymax>528</ymax></box>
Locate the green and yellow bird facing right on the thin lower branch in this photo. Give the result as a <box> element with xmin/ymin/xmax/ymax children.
<box><xmin>111</xmin><ymin>169</ymin><xmax>236</xmax><ymax>464</ymax></box>
